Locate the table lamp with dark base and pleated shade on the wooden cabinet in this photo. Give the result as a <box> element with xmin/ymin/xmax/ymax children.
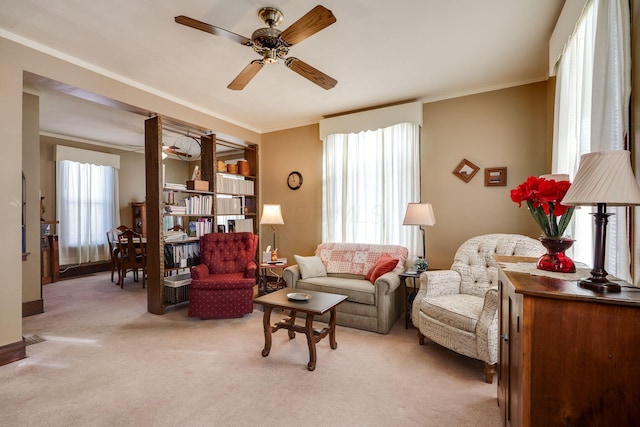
<box><xmin>561</xmin><ymin>150</ymin><xmax>640</xmax><ymax>292</ymax></box>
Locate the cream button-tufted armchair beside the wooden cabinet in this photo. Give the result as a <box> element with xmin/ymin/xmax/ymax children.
<box><xmin>411</xmin><ymin>234</ymin><xmax>545</xmax><ymax>383</ymax></box>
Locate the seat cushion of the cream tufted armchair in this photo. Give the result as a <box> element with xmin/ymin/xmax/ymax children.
<box><xmin>420</xmin><ymin>294</ymin><xmax>484</xmax><ymax>333</ymax></box>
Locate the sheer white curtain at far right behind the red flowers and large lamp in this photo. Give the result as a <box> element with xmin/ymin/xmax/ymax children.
<box><xmin>553</xmin><ymin>0</ymin><xmax>631</xmax><ymax>280</ymax></box>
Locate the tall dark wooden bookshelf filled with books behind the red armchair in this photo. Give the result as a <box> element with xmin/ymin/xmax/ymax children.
<box><xmin>145</xmin><ymin>116</ymin><xmax>258</xmax><ymax>314</ymax></box>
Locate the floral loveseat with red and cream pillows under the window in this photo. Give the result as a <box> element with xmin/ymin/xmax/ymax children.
<box><xmin>283</xmin><ymin>243</ymin><xmax>408</xmax><ymax>334</ymax></box>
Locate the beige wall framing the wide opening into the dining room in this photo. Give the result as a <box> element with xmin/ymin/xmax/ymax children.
<box><xmin>0</xmin><ymin>38</ymin><xmax>261</xmax><ymax>351</ymax></box>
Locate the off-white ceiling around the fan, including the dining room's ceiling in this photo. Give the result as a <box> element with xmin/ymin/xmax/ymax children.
<box><xmin>0</xmin><ymin>0</ymin><xmax>564</xmax><ymax>147</ymax></box>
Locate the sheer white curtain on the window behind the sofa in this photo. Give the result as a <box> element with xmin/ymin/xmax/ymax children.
<box><xmin>322</xmin><ymin>123</ymin><xmax>422</xmax><ymax>257</ymax></box>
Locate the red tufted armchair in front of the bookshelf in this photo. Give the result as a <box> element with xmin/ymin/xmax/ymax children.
<box><xmin>189</xmin><ymin>233</ymin><xmax>258</xmax><ymax>319</ymax></box>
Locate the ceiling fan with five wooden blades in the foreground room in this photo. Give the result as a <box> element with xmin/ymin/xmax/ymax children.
<box><xmin>175</xmin><ymin>5</ymin><xmax>338</xmax><ymax>90</ymax></box>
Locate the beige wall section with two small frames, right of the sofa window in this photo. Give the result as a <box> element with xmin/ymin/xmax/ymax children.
<box><xmin>421</xmin><ymin>82</ymin><xmax>548</xmax><ymax>268</ymax></box>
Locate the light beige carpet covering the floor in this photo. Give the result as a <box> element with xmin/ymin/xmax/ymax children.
<box><xmin>0</xmin><ymin>273</ymin><xmax>500</xmax><ymax>427</ymax></box>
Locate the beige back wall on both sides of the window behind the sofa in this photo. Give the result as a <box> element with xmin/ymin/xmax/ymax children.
<box><xmin>260</xmin><ymin>82</ymin><xmax>547</xmax><ymax>268</ymax></box>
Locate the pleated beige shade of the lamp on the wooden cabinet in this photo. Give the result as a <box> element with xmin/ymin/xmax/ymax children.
<box><xmin>561</xmin><ymin>150</ymin><xmax>640</xmax><ymax>206</ymax></box>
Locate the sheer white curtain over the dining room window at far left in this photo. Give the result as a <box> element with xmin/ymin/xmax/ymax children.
<box><xmin>56</xmin><ymin>160</ymin><xmax>120</xmax><ymax>265</ymax></box>
